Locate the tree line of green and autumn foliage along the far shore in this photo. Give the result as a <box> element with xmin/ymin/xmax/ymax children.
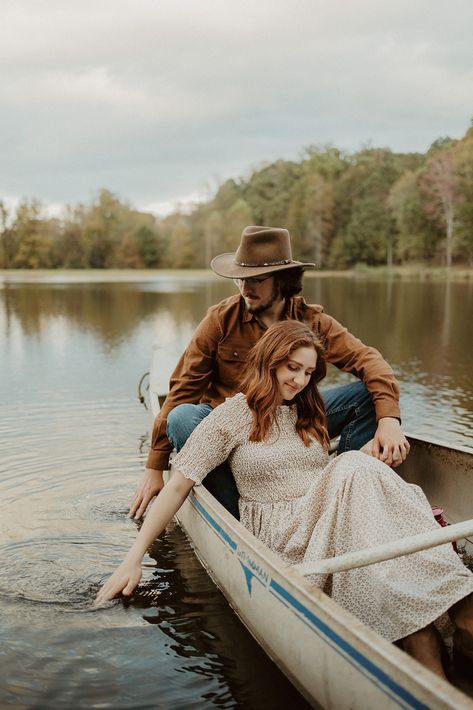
<box><xmin>0</xmin><ymin>122</ymin><xmax>473</xmax><ymax>269</ymax></box>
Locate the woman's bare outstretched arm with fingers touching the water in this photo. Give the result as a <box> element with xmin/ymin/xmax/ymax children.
<box><xmin>95</xmin><ymin>471</ymin><xmax>194</xmax><ymax>604</ymax></box>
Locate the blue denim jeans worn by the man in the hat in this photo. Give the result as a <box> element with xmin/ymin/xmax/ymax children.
<box><xmin>167</xmin><ymin>381</ymin><xmax>376</xmax><ymax>519</ymax></box>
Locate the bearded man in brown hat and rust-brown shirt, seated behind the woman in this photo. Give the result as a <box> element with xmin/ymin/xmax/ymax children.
<box><xmin>130</xmin><ymin>227</ymin><xmax>409</xmax><ymax>518</ymax></box>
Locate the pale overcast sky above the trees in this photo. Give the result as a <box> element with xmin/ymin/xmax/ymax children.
<box><xmin>0</xmin><ymin>0</ymin><xmax>473</xmax><ymax>217</ymax></box>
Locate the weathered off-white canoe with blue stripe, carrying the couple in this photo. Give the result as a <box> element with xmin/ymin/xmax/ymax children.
<box><xmin>150</xmin><ymin>373</ymin><xmax>473</xmax><ymax>710</ymax></box>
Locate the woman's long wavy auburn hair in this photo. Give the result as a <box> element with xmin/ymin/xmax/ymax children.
<box><xmin>240</xmin><ymin>320</ymin><xmax>330</xmax><ymax>447</ymax></box>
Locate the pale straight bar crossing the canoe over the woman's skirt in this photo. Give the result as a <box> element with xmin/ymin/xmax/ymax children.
<box><xmin>294</xmin><ymin>519</ymin><xmax>473</xmax><ymax>576</ymax></box>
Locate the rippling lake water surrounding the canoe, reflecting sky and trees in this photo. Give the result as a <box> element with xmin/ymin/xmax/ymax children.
<box><xmin>0</xmin><ymin>274</ymin><xmax>473</xmax><ymax>708</ymax></box>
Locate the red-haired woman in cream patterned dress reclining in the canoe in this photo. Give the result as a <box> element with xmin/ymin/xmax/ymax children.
<box><xmin>96</xmin><ymin>321</ymin><xmax>473</xmax><ymax>677</ymax></box>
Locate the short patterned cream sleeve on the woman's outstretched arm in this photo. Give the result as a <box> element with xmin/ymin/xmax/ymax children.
<box><xmin>172</xmin><ymin>394</ymin><xmax>247</xmax><ymax>483</ymax></box>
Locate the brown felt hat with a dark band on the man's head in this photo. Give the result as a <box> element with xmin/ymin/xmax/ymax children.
<box><xmin>210</xmin><ymin>227</ymin><xmax>315</xmax><ymax>279</ymax></box>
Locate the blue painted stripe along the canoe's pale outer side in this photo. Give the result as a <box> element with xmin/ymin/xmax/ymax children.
<box><xmin>188</xmin><ymin>496</ymin><xmax>429</xmax><ymax>710</ymax></box>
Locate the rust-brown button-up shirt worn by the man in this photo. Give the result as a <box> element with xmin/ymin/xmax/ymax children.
<box><xmin>146</xmin><ymin>294</ymin><xmax>400</xmax><ymax>470</ymax></box>
